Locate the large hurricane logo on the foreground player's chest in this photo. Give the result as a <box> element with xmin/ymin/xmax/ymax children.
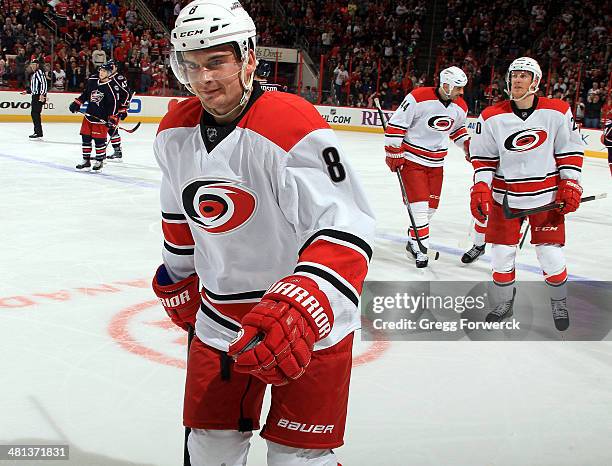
<box><xmin>182</xmin><ymin>179</ymin><xmax>257</xmax><ymax>234</ymax></box>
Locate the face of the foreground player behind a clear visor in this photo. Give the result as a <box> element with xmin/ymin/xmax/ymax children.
<box><xmin>183</xmin><ymin>45</ymin><xmax>255</xmax><ymax>114</ymax></box>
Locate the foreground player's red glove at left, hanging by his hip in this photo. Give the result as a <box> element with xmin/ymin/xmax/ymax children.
<box><xmin>152</xmin><ymin>264</ymin><xmax>201</xmax><ymax>330</ymax></box>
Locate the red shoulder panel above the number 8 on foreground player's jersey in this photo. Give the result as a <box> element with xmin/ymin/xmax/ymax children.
<box><xmin>237</xmin><ymin>92</ymin><xmax>329</xmax><ymax>152</ymax></box>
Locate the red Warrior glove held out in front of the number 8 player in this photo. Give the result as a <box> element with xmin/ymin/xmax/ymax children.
<box><xmin>228</xmin><ymin>275</ymin><xmax>334</xmax><ymax>385</ymax></box>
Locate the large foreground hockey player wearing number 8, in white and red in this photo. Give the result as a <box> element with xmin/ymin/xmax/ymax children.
<box><xmin>153</xmin><ymin>0</ymin><xmax>374</xmax><ymax>466</ymax></box>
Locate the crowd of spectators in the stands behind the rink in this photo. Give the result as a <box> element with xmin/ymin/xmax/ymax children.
<box><xmin>0</xmin><ymin>0</ymin><xmax>612</xmax><ymax>127</ymax></box>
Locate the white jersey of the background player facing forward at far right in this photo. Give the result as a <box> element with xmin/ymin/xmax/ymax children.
<box><xmin>470</xmin><ymin>97</ymin><xmax>584</xmax><ymax>209</ymax></box>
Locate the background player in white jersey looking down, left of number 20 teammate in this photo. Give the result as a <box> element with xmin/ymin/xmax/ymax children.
<box><xmin>385</xmin><ymin>66</ymin><xmax>470</xmax><ymax>268</ymax></box>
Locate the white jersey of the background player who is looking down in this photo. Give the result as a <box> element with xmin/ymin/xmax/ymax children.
<box><xmin>385</xmin><ymin>87</ymin><xmax>469</xmax><ymax>167</ymax></box>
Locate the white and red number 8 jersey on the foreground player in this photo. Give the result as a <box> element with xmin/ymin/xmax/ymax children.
<box><xmin>154</xmin><ymin>85</ymin><xmax>375</xmax><ymax>351</ymax></box>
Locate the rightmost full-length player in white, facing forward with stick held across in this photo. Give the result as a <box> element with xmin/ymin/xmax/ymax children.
<box><xmin>471</xmin><ymin>57</ymin><xmax>584</xmax><ymax>331</ymax></box>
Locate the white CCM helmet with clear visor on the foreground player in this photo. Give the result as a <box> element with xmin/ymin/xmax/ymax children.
<box><xmin>170</xmin><ymin>0</ymin><xmax>257</xmax><ymax>113</ymax></box>
